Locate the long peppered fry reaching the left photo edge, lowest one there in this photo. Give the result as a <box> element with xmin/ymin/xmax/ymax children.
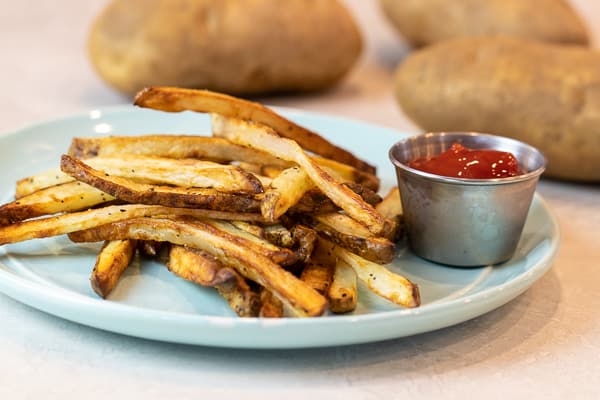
<box><xmin>0</xmin><ymin>204</ymin><xmax>265</xmax><ymax>245</ymax></box>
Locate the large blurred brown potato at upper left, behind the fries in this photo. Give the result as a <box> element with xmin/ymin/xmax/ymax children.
<box><xmin>88</xmin><ymin>0</ymin><xmax>362</xmax><ymax>94</ymax></box>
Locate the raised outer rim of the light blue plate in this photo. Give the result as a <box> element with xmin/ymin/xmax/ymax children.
<box><xmin>0</xmin><ymin>105</ymin><xmax>561</xmax><ymax>349</ymax></box>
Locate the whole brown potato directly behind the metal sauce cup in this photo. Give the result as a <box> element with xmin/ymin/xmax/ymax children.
<box><xmin>395</xmin><ymin>37</ymin><xmax>600</xmax><ymax>181</ymax></box>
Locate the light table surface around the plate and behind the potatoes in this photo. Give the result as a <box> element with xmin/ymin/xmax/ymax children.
<box><xmin>0</xmin><ymin>0</ymin><xmax>600</xmax><ymax>399</ymax></box>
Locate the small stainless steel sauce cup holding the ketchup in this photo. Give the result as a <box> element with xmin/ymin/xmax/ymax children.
<box><xmin>389</xmin><ymin>132</ymin><xmax>546</xmax><ymax>267</ymax></box>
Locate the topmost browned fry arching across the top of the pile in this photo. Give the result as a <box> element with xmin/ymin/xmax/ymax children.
<box><xmin>134</xmin><ymin>87</ymin><xmax>375</xmax><ymax>173</ymax></box>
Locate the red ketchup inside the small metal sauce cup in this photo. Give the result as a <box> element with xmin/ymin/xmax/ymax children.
<box><xmin>408</xmin><ymin>143</ymin><xmax>520</xmax><ymax>179</ymax></box>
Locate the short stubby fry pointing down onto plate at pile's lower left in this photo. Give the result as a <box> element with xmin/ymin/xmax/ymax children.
<box><xmin>90</xmin><ymin>239</ymin><xmax>137</xmax><ymax>298</ymax></box>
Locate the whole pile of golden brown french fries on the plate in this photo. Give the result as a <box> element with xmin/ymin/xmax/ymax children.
<box><xmin>0</xmin><ymin>87</ymin><xmax>420</xmax><ymax>317</ymax></box>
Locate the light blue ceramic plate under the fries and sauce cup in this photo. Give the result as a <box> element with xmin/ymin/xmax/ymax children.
<box><xmin>0</xmin><ymin>107</ymin><xmax>559</xmax><ymax>348</ymax></box>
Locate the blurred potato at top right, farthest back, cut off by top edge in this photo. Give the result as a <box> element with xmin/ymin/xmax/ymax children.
<box><xmin>380</xmin><ymin>0</ymin><xmax>588</xmax><ymax>46</ymax></box>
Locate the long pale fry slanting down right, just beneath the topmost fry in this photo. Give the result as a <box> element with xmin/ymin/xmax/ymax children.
<box><xmin>212</xmin><ymin>114</ymin><xmax>393</xmax><ymax>236</ymax></box>
